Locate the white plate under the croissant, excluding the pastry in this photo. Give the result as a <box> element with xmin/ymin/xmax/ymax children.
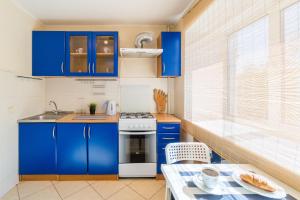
<box><xmin>232</xmin><ymin>170</ymin><xmax>286</xmax><ymax>199</ymax></box>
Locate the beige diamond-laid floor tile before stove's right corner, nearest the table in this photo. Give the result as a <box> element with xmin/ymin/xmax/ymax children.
<box><xmin>129</xmin><ymin>180</ymin><xmax>164</xmax><ymax>199</ymax></box>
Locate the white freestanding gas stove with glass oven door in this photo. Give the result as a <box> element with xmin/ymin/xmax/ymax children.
<box><xmin>119</xmin><ymin>112</ymin><xmax>156</xmax><ymax>177</ymax></box>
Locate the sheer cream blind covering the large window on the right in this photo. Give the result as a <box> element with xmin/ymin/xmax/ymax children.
<box><xmin>185</xmin><ymin>0</ymin><xmax>300</xmax><ymax>175</ymax></box>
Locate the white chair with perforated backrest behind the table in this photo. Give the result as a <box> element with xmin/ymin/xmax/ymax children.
<box><xmin>165</xmin><ymin>142</ymin><xmax>211</xmax><ymax>200</ymax></box>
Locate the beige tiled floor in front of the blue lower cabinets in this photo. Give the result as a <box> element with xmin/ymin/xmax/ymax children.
<box><xmin>1</xmin><ymin>179</ymin><xmax>165</xmax><ymax>200</ymax></box>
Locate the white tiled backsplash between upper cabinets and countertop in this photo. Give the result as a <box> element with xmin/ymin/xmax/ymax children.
<box><xmin>45</xmin><ymin>77</ymin><xmax>173</xmax><ymax>113</ymax></box>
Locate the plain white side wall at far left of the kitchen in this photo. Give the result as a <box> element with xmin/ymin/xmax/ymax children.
<box><xmin>0</xmin><ymin>0</ymin><xmax>45</xmax><ymax>197</ymax></box>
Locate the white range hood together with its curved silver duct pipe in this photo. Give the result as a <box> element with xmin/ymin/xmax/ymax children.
<box><xmin>120</xmin><ymin>32</ymin><xmax>163</xmax><ymax>58</ymax></box>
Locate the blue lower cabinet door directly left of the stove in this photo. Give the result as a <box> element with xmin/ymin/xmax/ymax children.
<box><xmin>88</xmin><ymin>123</ymin><xmax>119</xmax><ymax>174</ymax></box>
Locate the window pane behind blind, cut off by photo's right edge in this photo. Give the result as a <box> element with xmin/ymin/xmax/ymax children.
<box><xmin>282</xmin><ymin>2</ymin><xmax>300</xmax><ymax>127</ymax></box>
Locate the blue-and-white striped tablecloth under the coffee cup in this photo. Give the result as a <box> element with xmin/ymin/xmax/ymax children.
<box><xmin>162</xmin><ymin>164</ymin><xmax>297</xmax><ymax>200</ymax></box>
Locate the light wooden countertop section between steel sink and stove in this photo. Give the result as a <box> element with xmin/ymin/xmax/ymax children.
<box><xmin>56</xmin><ymin>114</ymin><xmax>119</xmax><ymax>123</ymax></box>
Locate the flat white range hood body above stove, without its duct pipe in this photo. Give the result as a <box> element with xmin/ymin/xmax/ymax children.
<box><xmin>120</xmin><ymin>48</ymin><xmax>163</xmax><ymax>58</ymax></box>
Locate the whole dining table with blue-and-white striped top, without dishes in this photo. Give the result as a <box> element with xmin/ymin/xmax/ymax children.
<box><xmin>161</xmin><ymin>164</ymin><xmax>300</xmax><ymax>200</ymax></box>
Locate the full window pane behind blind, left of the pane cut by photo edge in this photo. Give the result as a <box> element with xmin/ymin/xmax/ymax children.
<box><xmin>228</xmin><ymin>17</ymin><xmax>269</xmax><ymax>120</ymax></box>
